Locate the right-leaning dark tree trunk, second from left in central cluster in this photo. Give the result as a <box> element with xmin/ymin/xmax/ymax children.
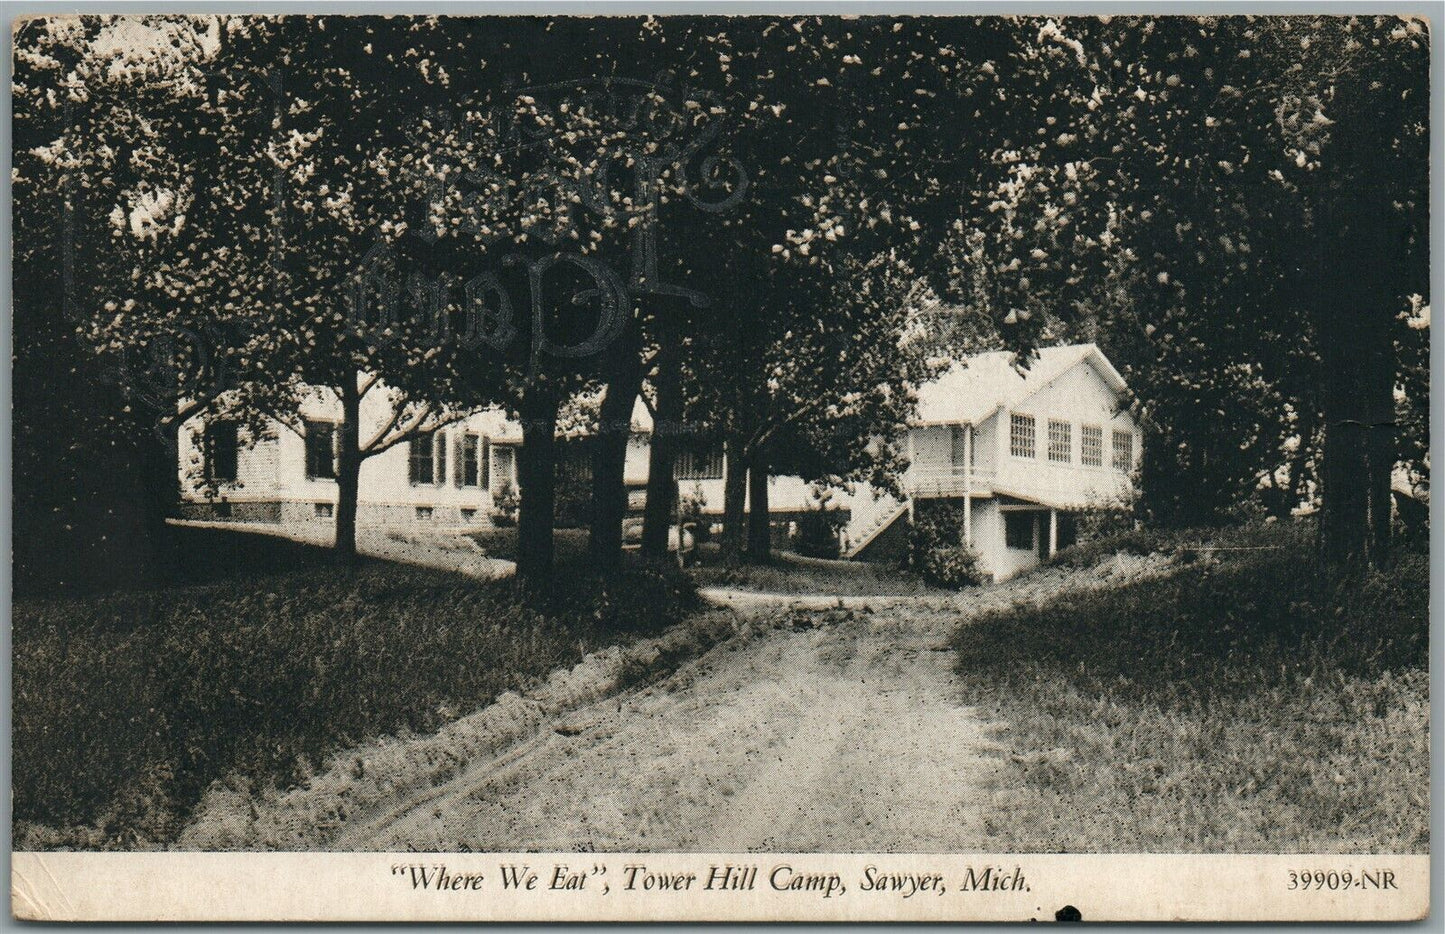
<box><xmin>587</xmin><ymin>327</ymin><xmax>642</xmax><ymax>574</ymax></box>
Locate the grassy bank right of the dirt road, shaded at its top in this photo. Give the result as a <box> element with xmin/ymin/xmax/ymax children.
<box><xmin>955</xmin><ymin>525</ymin><xmax>1429</xmax><ymax>853</ymax></box>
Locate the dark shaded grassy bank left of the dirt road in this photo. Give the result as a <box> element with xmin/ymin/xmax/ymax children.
<box><xmin>12</xmin><ymin>537</ymin><xmax>694</xmax><ymax>846</ymax></box>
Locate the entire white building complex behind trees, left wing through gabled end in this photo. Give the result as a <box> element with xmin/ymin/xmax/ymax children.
<box><xmin>179</xmin><ymin>344</ymin><xmax>1142</xmax><ymax>580</ymax></box>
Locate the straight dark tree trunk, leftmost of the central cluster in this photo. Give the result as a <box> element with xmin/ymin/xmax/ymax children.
<box><xmin>517</xmin><ymin>386</ymin><xmax>558</xmax><ymax>586</ymax></box>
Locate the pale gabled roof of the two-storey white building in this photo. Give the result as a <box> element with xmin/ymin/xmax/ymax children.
<box><xmin>913</xmin><ymin>344</ymin><xmax>1126</xmax><ymax>425</ymax></box>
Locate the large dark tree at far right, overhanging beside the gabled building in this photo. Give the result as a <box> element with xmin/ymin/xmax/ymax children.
<box><xmin>955</xmin><ymin>17</ymin><xmax>1426</xmax><ymax>562</ymax></box>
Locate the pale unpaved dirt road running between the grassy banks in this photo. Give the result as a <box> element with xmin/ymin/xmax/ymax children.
<box><xmin>334</xmin><ymin>601</ymin><xmax>996</xmax><ymax>852</ymax></box>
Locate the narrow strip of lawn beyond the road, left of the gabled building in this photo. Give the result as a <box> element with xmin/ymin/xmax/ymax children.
<box><xmin>689</xmin><ymin>545</ymin><xmax>954</xmax><ymax>597</ymax></box>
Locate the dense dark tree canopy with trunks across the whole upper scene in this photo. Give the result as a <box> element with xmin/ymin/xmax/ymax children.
<box><xmin>14</xmin><ymin>16</ymin><xmax>1429</xmax><ymax>592</ymax></box>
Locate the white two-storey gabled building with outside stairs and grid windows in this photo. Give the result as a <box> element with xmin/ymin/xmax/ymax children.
<box><xmin>847</xmin><ymin>344</ymin><xmax>1143</xmax><ymax>580</ymax></box>
